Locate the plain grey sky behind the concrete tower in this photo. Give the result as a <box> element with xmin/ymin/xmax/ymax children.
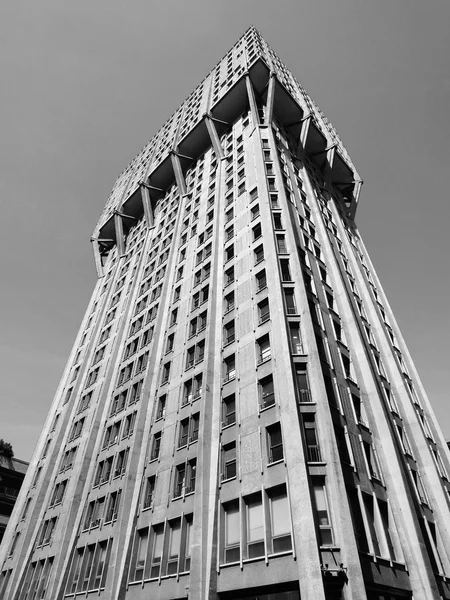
<box><xmin>0</xmin><ymin>0</ymin><xmax>450</xmax><ymax>460</ymax></box>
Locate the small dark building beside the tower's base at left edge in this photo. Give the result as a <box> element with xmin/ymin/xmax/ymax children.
<box><xmin>0</xmin><ymin>452</ymin><xmax>29</xmax><ymax>544</ymax></box>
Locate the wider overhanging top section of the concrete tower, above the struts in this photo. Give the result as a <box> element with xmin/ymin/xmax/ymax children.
<box><xmin>94</xmin><ymin>27</ymin><xmax>360</xmax><ymax>239</ymax></box>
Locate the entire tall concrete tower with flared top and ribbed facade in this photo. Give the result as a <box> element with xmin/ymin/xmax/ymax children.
<box><xmin>0</xmin><ymin>27</ymin><xmax>450</xmax><ymax>600</ymax></box>
